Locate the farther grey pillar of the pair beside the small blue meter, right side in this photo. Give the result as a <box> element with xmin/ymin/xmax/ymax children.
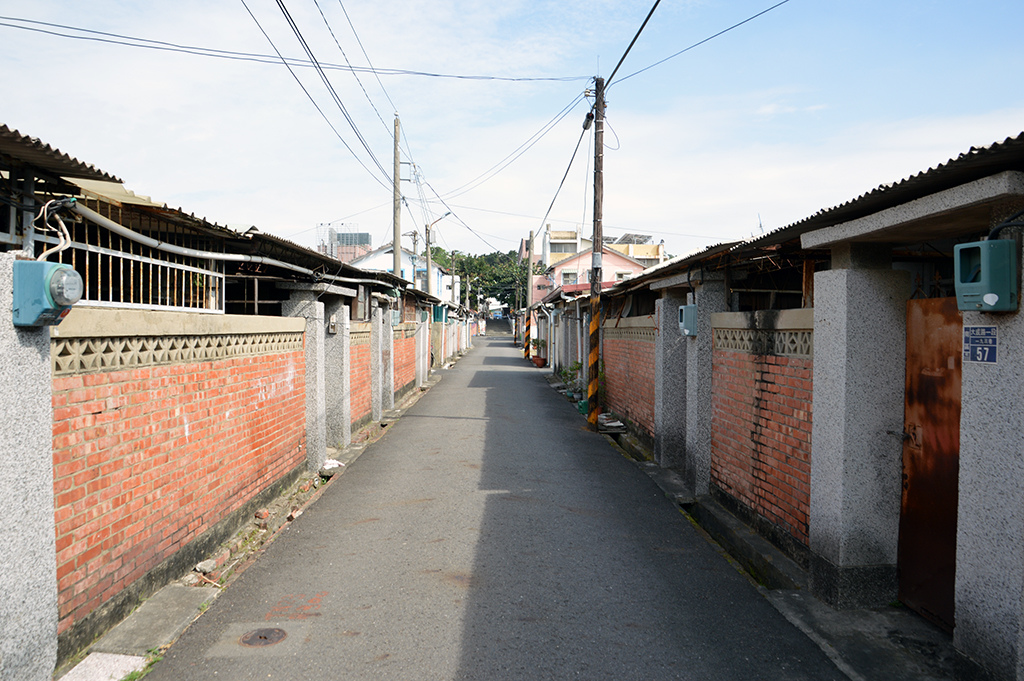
<box><xmin>654</xmin><ymin>289</ymin><xmax>687</xmax><ymax>468</ymax></box>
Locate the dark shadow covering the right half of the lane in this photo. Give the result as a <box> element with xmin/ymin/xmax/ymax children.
<box><xmin>456</xmin><ymin>341</ymin><xmax>844</xmax><ymax>681</ymax></box>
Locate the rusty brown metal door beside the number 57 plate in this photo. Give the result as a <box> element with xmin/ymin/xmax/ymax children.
<box><xmin>898</xmin><ymin>298</ymin><xmax>964</xmax><ymax>629</ymax></box>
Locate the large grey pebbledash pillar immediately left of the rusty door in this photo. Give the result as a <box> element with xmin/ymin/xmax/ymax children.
<box><xmin>809</xmin><ymin>245</ymin><xmax>911</xmax><ymax>608</ymax></box>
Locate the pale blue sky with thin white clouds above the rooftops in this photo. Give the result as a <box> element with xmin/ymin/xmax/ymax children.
<box><xmin>0</xmin><ymin>0</ymin><xmax>1024</xmax><ymax>260</ymax></box>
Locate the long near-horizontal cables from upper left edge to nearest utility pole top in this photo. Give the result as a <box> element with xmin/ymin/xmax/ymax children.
<box><xmin>0</xmin><ymin>16</ymin><xmax>590</xmax><ymax>83</ymax></box>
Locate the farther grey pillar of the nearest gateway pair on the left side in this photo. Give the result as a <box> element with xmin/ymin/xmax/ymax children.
<box><xmin>324</xmin><ymin>296</ymin><xmax>352</xmax><ymax>449</ymax></box>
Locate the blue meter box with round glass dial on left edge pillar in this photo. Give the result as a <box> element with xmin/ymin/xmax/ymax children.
<box><xmin>13</xmin><ymin>260</ymin><xmax>85</xmax><ymax>327</ymax></box>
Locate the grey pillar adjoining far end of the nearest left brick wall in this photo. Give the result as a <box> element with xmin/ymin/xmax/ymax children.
<box><xmin>281</xmin><ymin>291</ymin><xmax>327</xmax><ymax>472</ymax></box>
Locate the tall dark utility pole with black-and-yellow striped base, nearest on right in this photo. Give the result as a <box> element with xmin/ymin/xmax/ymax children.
<box><xmin>587</xmin><ymin>78</ymin><xmax>604</xmax><ymax>428</ymax></box>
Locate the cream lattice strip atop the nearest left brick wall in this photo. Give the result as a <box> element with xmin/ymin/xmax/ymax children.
<box><xmin>50</xmin><ymin>332</ymin><xmax>302</xmax><ymax>376</ymax></box>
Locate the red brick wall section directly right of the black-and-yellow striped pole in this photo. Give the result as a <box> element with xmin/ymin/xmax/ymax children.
<box><xmin>601</xmin><ymin>327</ymin><xmax>654</xmax><ymax>437</ymax></box>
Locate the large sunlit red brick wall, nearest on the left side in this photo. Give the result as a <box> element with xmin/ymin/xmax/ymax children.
<box><xmin>53</xmin><ymin>351</ymin><xmax>305</xmax><ymax>633</ymax></box>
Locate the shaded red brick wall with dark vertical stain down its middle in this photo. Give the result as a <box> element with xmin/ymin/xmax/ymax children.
<box><xmin>711</xmin><ymin>350</ymin><xmax>812</xmax><ymax>545</ymax></box>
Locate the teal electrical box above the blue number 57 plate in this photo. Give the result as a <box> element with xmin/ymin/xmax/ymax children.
<box><xmin>953</xmin><ymin>239</ymin><xmax>1019</xmax><ymax>312</ymax></box>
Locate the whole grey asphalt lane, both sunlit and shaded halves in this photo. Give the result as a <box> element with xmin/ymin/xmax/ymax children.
<box><xmin>147</xmin><ymin>336</ymin><xmax>846</xmax><ymax>681</ymax></box>
